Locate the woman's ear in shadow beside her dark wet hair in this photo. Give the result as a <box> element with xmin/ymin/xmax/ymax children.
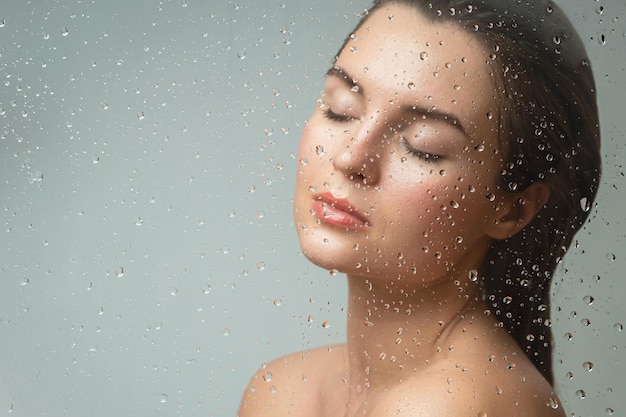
<box><xmin>489</xmin><ymin>181</ymin><xmax>550</xmax><ymax>240</ymax></box>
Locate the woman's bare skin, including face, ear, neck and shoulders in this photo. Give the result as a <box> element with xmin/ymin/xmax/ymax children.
<box><xmin>238</xmin><ymin>5</ymin><xmax>565</xmax><ymax>417</ymax></box>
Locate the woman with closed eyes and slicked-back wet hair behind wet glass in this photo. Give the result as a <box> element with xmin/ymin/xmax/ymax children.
<box><xmin>239</xmin><ymin>0</ymin><xmax>600</xmax><ymax>417</ymax></box>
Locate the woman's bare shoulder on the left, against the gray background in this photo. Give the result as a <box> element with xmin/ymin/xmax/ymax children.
<box><xmin>238</xmin><ymin>345</ymin><xmax>347</xmax><ymax>417</ymax></box>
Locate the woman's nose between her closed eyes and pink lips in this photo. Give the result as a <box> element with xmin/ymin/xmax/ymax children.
<box><xmin>333</xmin><ymin>118</ymin><xmax>388</xmax><ymax>185</ymax></box>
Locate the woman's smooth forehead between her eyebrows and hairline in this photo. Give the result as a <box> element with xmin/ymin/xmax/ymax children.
<box><xmin>336</xmin><ymin>5</ymin><xmax>497</xmax><ymax>136</ymax></box>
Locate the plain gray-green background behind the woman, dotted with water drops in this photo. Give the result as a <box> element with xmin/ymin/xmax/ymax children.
<box><xmin>0</xmin><ymin>0</ymin><xmax>626</xmax><ymax>416</ymax></box>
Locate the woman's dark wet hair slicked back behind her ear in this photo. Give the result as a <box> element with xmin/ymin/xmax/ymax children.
<box><xmin>342</xmin><ymin>0</ymin><xmax>601</xmax><ymax>383</ymax></box>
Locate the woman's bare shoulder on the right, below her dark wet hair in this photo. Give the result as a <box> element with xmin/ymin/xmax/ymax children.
<box><xmin>371</xmin><ymin>328</ymin><xmax>565</xmax><ymax>417</ymax></box>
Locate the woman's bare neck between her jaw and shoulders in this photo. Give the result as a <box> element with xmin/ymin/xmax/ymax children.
<box><xmin>347</xmin><ymin>274</ymin><xmax>482</xmax><ymax>408</ymax></box>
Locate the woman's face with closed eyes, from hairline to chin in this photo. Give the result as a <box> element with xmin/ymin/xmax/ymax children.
<box><xmin>294</xmin><ymin>5</ymin><xmax>505</xmax><ymax>283</ymax></box>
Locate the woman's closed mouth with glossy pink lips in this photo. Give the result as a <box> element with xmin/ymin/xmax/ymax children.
<box><xmin>312</xmin><ymin>193</ymin><xmax>370</xmax><ymax>230</ymax></box>
